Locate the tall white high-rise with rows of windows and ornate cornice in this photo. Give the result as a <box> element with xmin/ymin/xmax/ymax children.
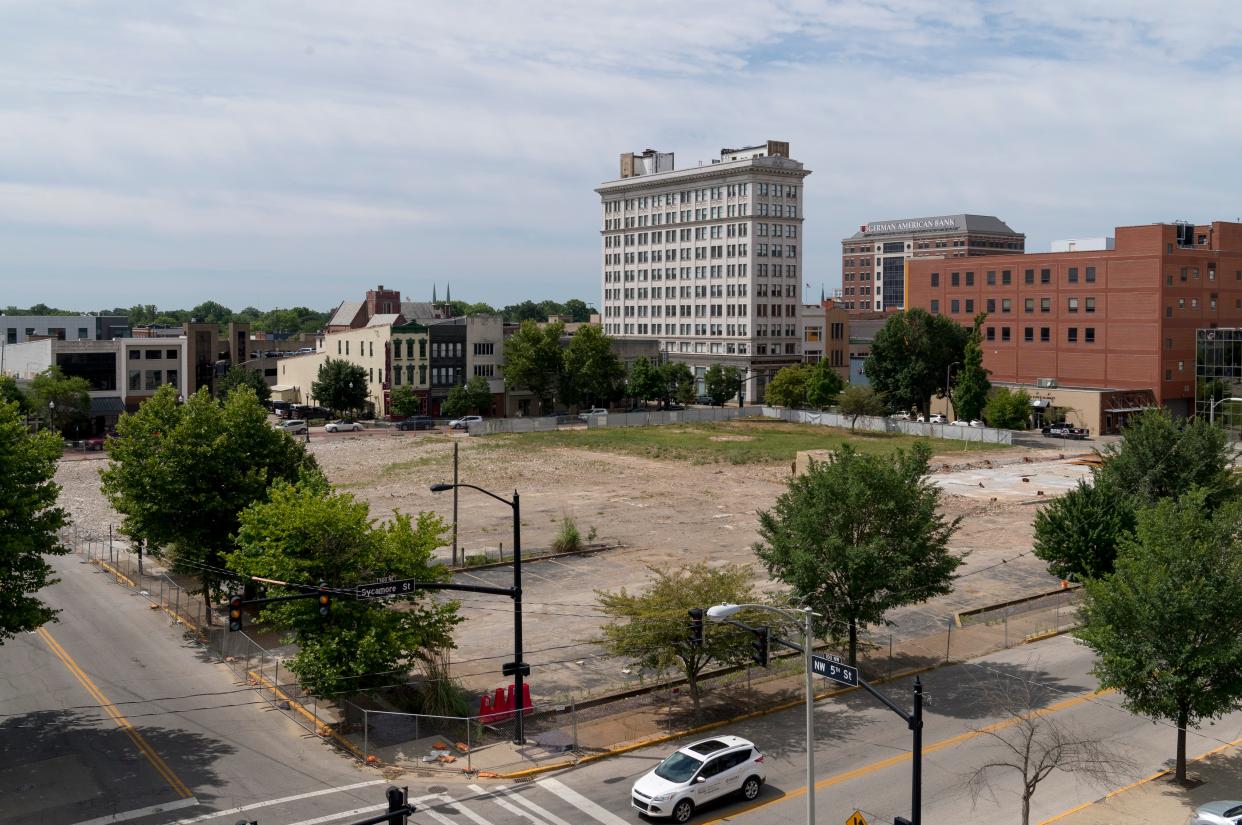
<box><xmin>595</xmin><ymin>140</ymin><xmax>811</xmax><ymax>401</ymax></box>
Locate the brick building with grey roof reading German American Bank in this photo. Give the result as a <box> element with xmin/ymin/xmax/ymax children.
<box><xmin>841</xmin><ymin>215</ymin><xmax>1026</xmax><ymax>312</ymax></box>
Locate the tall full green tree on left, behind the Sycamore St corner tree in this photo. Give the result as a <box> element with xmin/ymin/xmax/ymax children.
<box><xmin>101</xmin><ymin>384</ymin><xmax>319</xmax><ymax>624</ymax></box>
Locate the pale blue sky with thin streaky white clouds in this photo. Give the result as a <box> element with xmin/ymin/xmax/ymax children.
<box><xmin>0</xmin><ymin>0</ymin><xmax>1242</xmax><ymax>309</ymax></box>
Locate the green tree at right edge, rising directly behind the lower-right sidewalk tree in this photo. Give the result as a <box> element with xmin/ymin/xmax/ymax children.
<box><xmin>1099</xmin><ymin>408</ymin><xmax>1240</xmax><ymax>507</ymax></box>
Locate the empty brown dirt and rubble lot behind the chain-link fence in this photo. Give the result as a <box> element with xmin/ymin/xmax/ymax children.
<box><xmin>58</xmin><ymin>424</ymin><xmax>1092</xmax><ymax>700</ymax></box>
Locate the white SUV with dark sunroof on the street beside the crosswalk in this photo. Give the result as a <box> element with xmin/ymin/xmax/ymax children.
<box><xmin>630</xmin><ymin>736</ymin><xmax>768</xmax><ymax>823</ymax></box>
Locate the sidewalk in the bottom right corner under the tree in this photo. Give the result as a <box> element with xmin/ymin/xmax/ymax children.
<box><xmin>1040</xmin><ymin>741</ymin><xmax>1242</xmax><ymax>825</ymax></box>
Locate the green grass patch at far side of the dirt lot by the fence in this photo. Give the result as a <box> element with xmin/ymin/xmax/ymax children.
<box><xmin>494</xmin><ymin>420</ymin><xmax>1007</xmax><ymax>465</ymax></box>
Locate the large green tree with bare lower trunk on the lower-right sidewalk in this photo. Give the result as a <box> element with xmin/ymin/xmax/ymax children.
<box><xmin>1074</xmin><ymin>490</ymin><xmax>1242</xmax><ymax>783</ymax></box>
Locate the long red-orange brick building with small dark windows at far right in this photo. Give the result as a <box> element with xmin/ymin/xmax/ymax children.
<box><xmin>905</xmin><ymin>221</ymin><xmax>1242</xmax><ymax>422</ymax></box>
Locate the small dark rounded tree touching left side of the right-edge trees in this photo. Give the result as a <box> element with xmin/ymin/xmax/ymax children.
<box><xmin>1035</xmin><ymin>478</ymin><xmax>1134</xmax><ymax>581</ymax></box>
